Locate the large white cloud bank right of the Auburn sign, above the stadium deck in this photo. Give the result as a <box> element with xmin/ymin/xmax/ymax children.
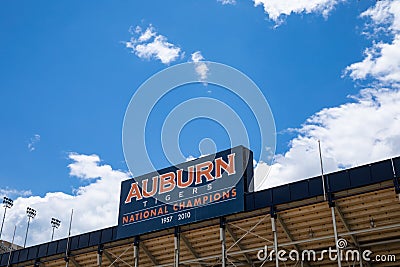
<box><xmin>255</xmin><ymin>89</ymin><xmax>400</xmax><ymax>190</ymax></box>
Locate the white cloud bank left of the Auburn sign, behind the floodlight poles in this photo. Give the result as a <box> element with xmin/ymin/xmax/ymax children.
<box><xmin>0</xmin><ymin>153</ymin><xmax>129</xmax><ymax>246</ymax></box>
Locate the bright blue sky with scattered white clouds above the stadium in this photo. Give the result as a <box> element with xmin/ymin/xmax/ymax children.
<box><xmin>0</xmin><ymin>0</ymin><xmax>400</xmax><ymax>246</ymax></box>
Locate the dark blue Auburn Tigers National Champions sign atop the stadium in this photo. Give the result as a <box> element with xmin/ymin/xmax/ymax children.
<box><xmin>117</xmin><ymin>146</ymin><xmax>253</xmax><ymax>241</ymax></box>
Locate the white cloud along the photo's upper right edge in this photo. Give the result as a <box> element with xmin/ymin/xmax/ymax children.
<box><xmin>345</xmin><ymin>1</ymin><xmax>400</xmax><ymax>86</ymax></box>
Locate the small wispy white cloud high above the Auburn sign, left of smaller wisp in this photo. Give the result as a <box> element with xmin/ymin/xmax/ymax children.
<box><xmin>125</xmin><ymin>25</ymin><xmax>181</xmax><ymax>64</ymax></box>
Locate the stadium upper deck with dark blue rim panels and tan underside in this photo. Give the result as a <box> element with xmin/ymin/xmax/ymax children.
<box><xmin>0</xmin><ymin>157</ymin><xmax>400</xmax><ymax>267</ymax></box>
